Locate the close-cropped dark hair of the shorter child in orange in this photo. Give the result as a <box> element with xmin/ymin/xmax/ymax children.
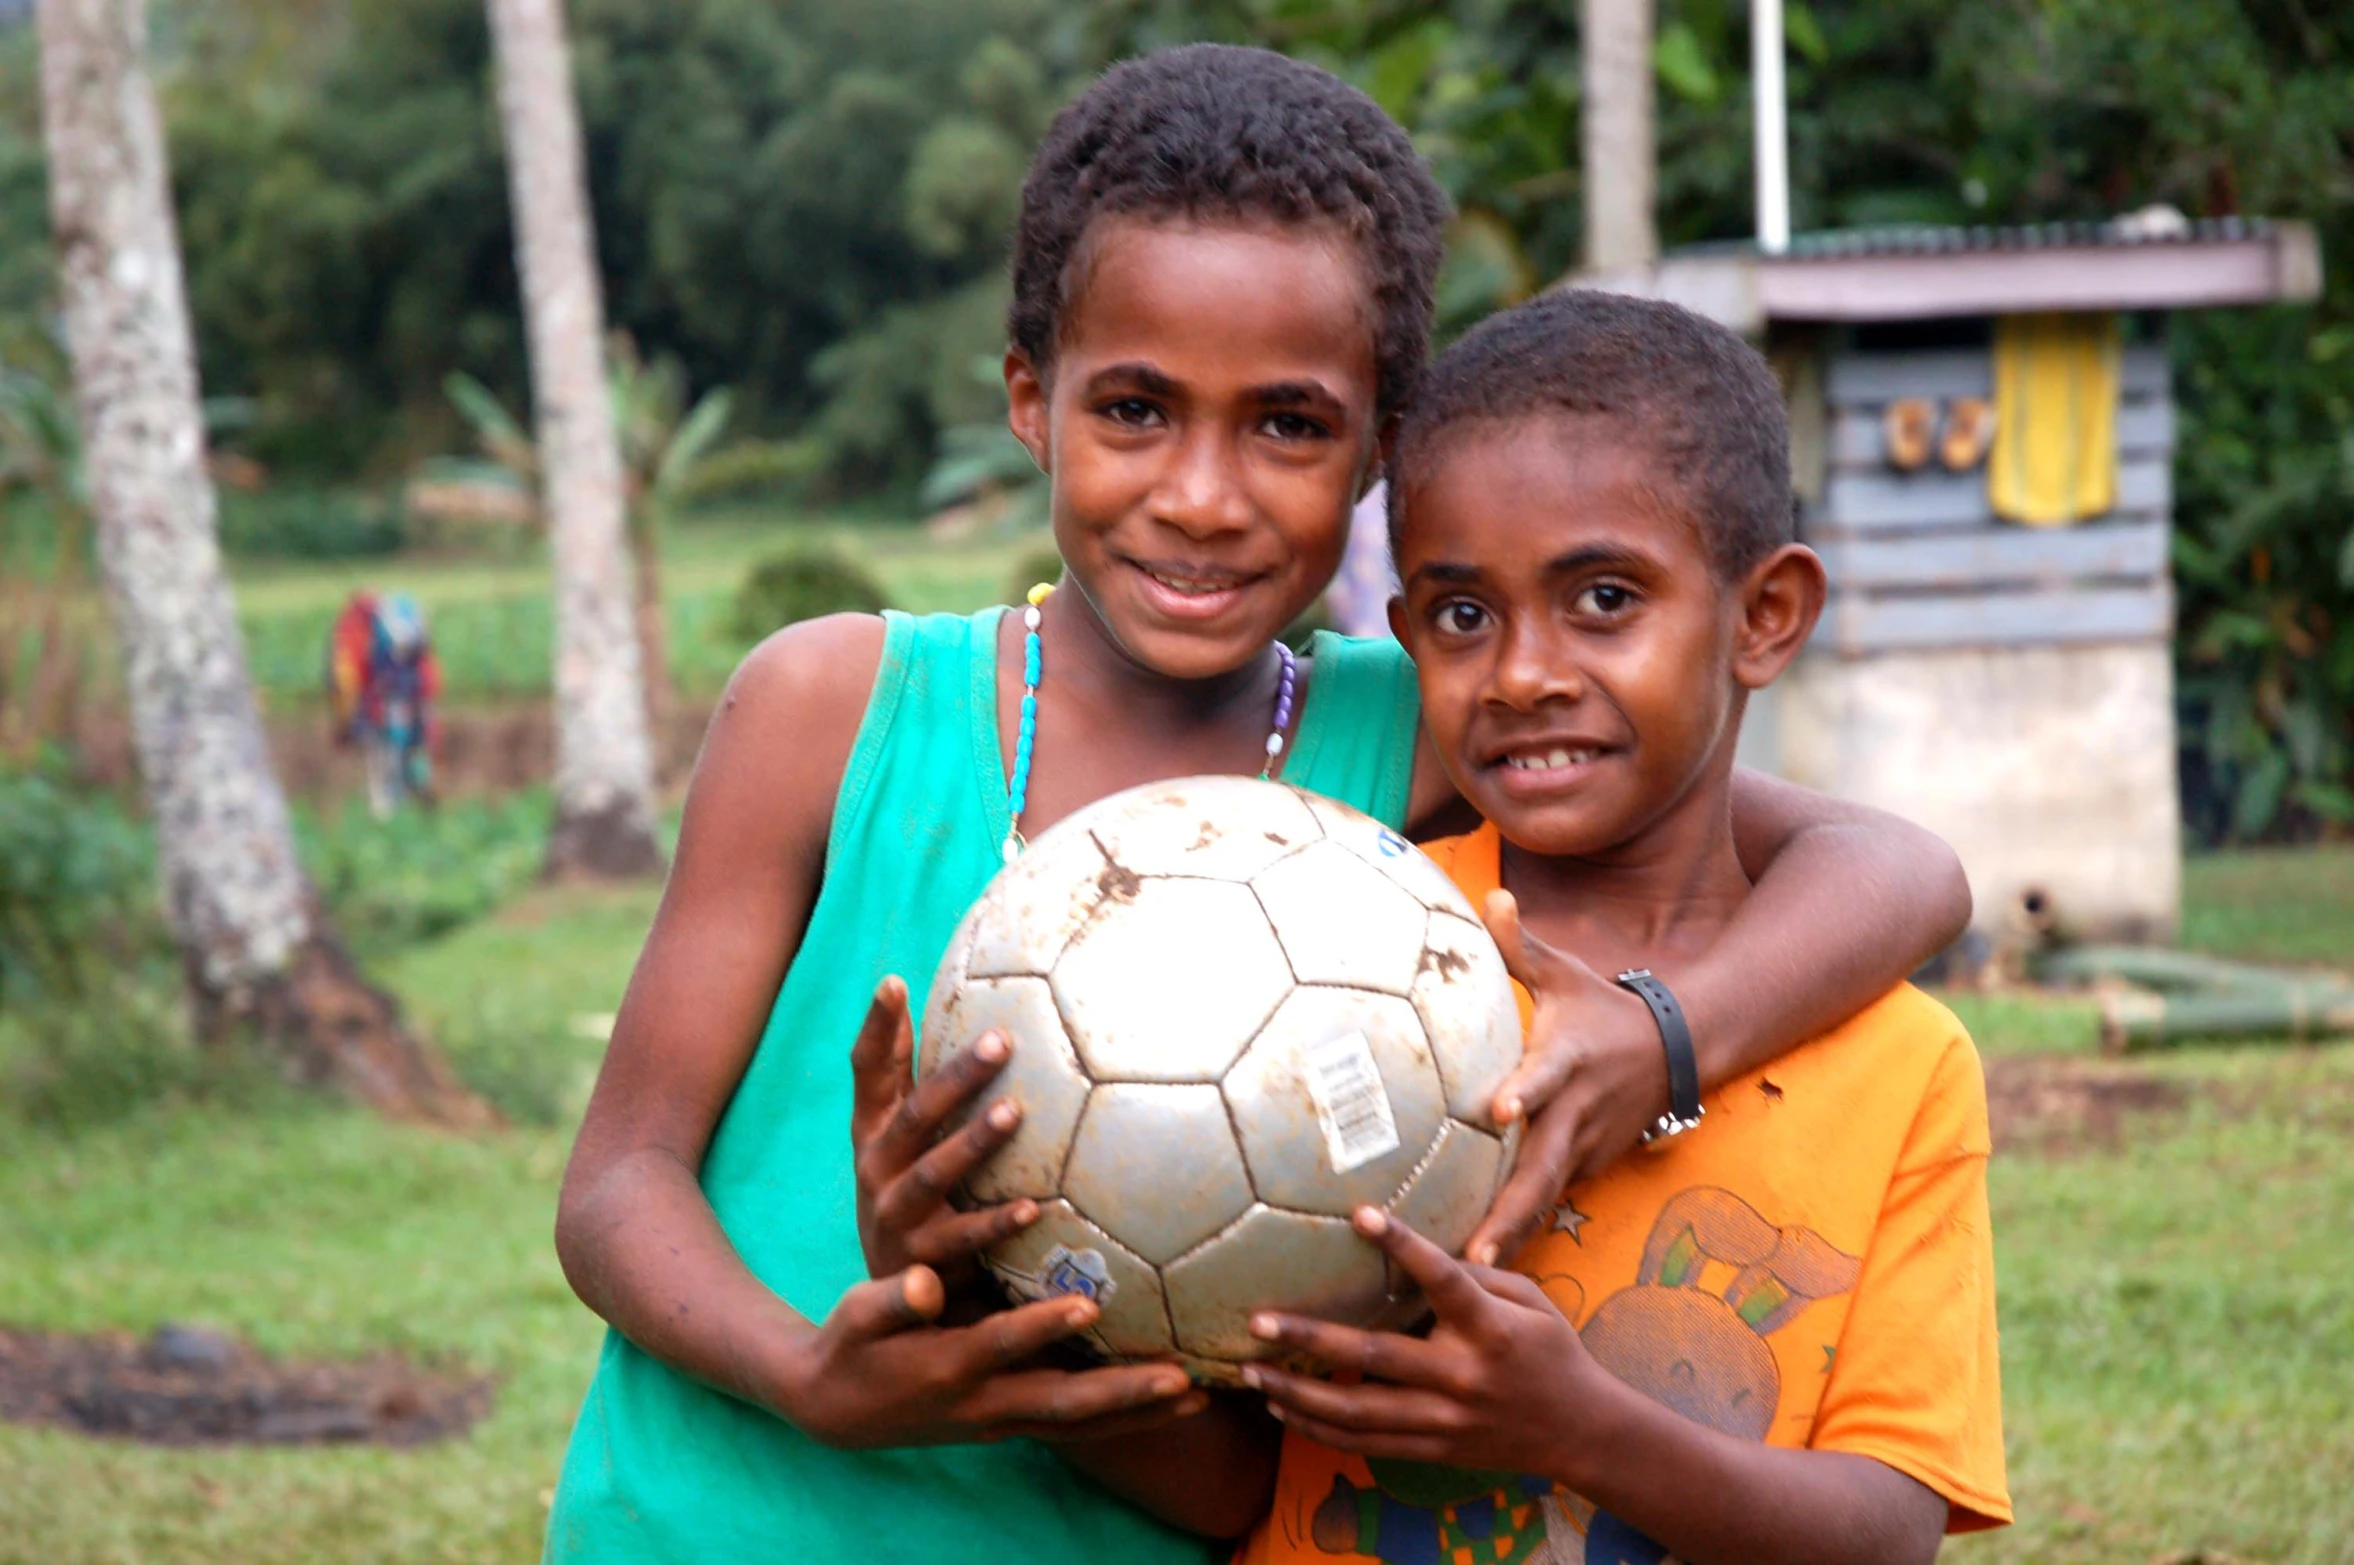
<box><xmin>1389</xmin><ymin>287</ymin><xmax>1798</xmax><ymax>581</ymax></box>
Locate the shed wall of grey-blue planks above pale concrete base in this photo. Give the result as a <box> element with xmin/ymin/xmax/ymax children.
<box><xmin>1742</xmin><ymin>334</ymin><xmax>2180</xmax><ymax>939</ymax></box>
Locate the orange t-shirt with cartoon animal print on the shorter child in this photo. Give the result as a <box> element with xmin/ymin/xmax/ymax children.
<box><xmin>1236</xmin><ymin>826</ymin><xmax>2010</xmax><ymax>1565</ymax></box>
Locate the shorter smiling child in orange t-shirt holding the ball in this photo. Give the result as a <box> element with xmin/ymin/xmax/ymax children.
<box><xmin>1241</xmin><ymin>292</ymin><xmax>2010</xmax><ymax>1565</ymax></box>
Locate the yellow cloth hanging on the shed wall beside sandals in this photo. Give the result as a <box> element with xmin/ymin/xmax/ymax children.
<box><xmin>1987</xmin><ymin>315</ymin><xmax>2123</xmax><ymax>527</ymax></box>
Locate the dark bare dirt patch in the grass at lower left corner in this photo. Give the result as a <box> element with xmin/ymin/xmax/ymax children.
<box><xmin>0</xmin><ymin>1325</ymin><xmax>494</xmax><ymax>1445</ymax></box>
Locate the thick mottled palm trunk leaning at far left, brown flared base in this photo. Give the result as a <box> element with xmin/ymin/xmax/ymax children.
<box><xmin>38</xmin><ymin>0</ymin><xmax>490</xmax><ymax>1123</ymax></box>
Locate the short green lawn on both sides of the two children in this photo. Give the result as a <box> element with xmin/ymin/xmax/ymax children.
<box><xmin>0</xmin><ymin>854</ymin><xmax>2354</xmax><ymax>1565</ymax></box>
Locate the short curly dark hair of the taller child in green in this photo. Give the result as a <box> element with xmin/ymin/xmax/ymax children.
<box><xmin>1005</xmin><ymin>45</ymin><xmax>1448</xmax><ymax>414</ymax></box>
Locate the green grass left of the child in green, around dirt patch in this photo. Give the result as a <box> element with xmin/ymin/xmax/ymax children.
<box><xmin>0</xmin><ymin>892</ymin><xmax>652</xmax><ymax>1565</ymax></box>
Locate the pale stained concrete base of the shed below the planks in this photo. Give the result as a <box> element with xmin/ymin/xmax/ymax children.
<box><xmin>1742</xmin><ymin>642</ymin><xmax>2182</xmax><ymax>941</ymax></box>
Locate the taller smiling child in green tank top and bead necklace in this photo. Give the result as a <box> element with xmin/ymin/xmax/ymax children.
<box><xmin>548</xmin><ymin>47</ymin><xmax>1966</xmax><ymax>1560</ymax></box>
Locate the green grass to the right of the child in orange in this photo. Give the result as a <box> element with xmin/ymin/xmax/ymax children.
<box><xmin>1949</xmin><ymin>1045</ymin><xmax>2354</xmax><ymax>1565</ymax></box>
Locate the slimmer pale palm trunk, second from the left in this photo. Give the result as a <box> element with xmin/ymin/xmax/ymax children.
<box><xmin>490</xmin><ymin>0</ymin><xmax>661</xmax><ymax>878</ymax></box>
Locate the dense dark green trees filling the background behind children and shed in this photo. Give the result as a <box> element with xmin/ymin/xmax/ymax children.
<box><xmin>0</xmin><ymin>0</ymin><xmax>2354</xmax><ymax>838</ymax></box>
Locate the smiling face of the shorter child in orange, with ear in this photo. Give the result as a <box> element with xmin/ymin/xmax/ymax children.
<box><xmin>1391</xmin><ymin>414</ymin><xmax>1822</xmax><ymax>859</ymax></box>
